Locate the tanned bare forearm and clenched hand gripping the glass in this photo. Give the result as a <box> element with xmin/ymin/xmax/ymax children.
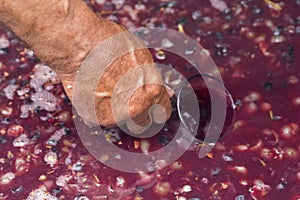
<box><xmin>0</xmin><ymin>0</ymin><xmax>171</xmax><ymax>133</ymax></box>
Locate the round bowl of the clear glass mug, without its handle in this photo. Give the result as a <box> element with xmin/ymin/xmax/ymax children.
<box><xmin>176</xmin><ymin>74</ymin><xmax>236</xmax><ymax>142</ymax></box>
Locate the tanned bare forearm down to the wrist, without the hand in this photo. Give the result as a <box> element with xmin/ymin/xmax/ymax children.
<box><xmin>0</xmin><ymin>0</ymin><xmax>121</xmax><ymax>73</ymax></box>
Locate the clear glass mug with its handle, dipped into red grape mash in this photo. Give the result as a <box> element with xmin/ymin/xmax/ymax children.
<box><xmin>161</xmin><ymin>67</ymin><xmax>236</xmax><ymax>143</ymax></box>
